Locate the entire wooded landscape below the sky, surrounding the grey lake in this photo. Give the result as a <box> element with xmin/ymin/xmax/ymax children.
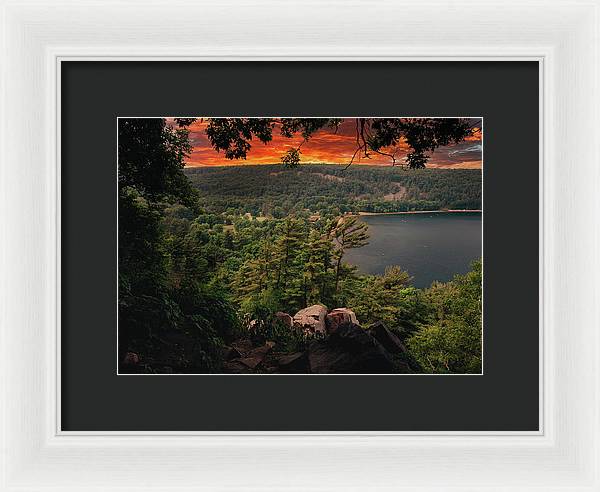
<box><xmin>119</xmin><ymin>119</ymin><xmax>482</xmax><ymax>373</ymax></box>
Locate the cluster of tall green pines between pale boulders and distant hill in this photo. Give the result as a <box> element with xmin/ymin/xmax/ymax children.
<box><xmin>220</xmin><ymin>212</ymin><xmax>376</xmax><ymax>312</ymax></box>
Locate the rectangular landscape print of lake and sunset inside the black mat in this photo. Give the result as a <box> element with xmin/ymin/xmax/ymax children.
<box><xmin>117</xmin><ymin>117</ymin><xmax>483</xmax><ymax>374</ymax></box>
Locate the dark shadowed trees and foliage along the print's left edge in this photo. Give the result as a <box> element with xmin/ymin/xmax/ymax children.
<box><xmin>119</xmin><ymin>118</ymin><xmax>237</xmax><ymax>372</ymax></box>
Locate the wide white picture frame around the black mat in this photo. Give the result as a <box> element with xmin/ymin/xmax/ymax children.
<box><xmin>0</xmin><ymin>0</ymin><xmax>600</xmax><ymax>491</ymax></box>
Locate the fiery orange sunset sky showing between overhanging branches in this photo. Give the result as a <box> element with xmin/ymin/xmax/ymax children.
<box><xmin>169</xmin><ymin>118</ymin><xmax>482</xmax><ymax>169</ymax></box>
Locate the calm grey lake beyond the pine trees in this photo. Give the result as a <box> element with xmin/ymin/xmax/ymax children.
<box><xmin>344</xmin><ymin>212</ymin><xmax>481</xmax><ymax>288</ymax></box>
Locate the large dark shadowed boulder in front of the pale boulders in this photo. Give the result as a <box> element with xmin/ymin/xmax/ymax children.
<box><xmin>308</xmin><ymin>323</ymin><xmax>394</xmax><ymax>374</ymax></box>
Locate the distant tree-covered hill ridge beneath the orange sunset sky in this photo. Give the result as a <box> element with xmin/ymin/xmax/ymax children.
<box><xmin>185</xmin><ymin>164</ymin><xmax>482</xmax><ymax>218</ymax></box>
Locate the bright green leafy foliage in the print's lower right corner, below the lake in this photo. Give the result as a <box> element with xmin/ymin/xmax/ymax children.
<box><xmin>408</xmin><ymin>261</ymin><xmax>482</xmax><ymax>374</ymax></box>
